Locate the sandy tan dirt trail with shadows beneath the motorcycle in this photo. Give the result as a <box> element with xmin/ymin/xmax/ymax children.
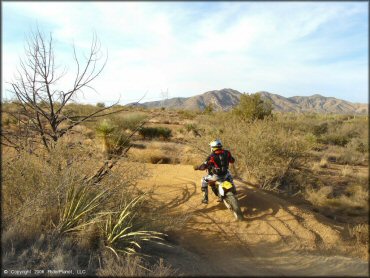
<box><xmin>139</xmin><ymin>164</ymin><xmax>369</xmax><ymax>276</ymax></box>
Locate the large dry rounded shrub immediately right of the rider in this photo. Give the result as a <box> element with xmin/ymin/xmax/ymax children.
<box><xmin>194</xmin><ymin>113</ymin><xmax>311</xmax><ymax>189</ymax></box>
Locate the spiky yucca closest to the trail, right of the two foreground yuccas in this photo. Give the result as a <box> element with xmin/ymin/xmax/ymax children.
<box><xmin>104</xmin><ymin>195</ymin><xmax>166</xmax><ymax>258</ymax></box>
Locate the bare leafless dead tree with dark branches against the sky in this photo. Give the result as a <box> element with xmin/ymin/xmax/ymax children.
<box><xmin>2</xmin><ymin>30</ymin><xmax>117</xmax><ymax>151</ymax></box>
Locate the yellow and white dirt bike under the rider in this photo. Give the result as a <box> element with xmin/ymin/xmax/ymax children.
<box><xmin>194</xmin><ymin>164</ymin><xmax>244</xmax><ymax>220</ymax></box>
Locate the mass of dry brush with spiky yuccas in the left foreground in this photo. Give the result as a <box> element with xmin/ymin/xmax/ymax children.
<box><xmin>1</xmin><ymin>142</ymin><xmax>178</xmax><ymax>276</ymax></box>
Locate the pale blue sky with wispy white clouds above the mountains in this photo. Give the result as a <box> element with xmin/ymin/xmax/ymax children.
<box><xmin>1</xmin><ymin>1</ymin><xmax>369</xmax><ymax>104</ymax></box>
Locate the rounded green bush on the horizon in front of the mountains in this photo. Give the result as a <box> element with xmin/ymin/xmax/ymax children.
<box><xmin>233</xmin><ymin>94</ymin><xmax>272</xmax><ymax>121</ymax></box>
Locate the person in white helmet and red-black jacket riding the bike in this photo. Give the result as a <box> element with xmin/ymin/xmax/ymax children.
<box><xmin>194</xmin><ymin>139</ymin><xmax>236</xmax><ymax>204</ymax></box>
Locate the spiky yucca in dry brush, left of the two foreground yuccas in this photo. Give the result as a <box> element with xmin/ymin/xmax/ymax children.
<box><xmin>56</xmin><ymin>185</ymin><xmax>107</xmax><ymax>234</ymax></box>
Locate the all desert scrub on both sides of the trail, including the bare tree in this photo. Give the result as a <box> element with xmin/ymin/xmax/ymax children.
<box><xmin>1</xmin><ymin>28</ymin><xmax>369</xmax><ymax>276</ymax></box>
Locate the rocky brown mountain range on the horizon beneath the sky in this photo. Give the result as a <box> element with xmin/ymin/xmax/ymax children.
<box><xmin>129</xmin><ymin>89</ymin><xmax>368</xmax><ymax>114</ymax></box>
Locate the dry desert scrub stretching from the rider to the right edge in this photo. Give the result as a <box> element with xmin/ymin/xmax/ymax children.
<box><xmin>193</xmin><ymin>108</ymin><xmax>368</xmax><ymax>214</ymax></box>
